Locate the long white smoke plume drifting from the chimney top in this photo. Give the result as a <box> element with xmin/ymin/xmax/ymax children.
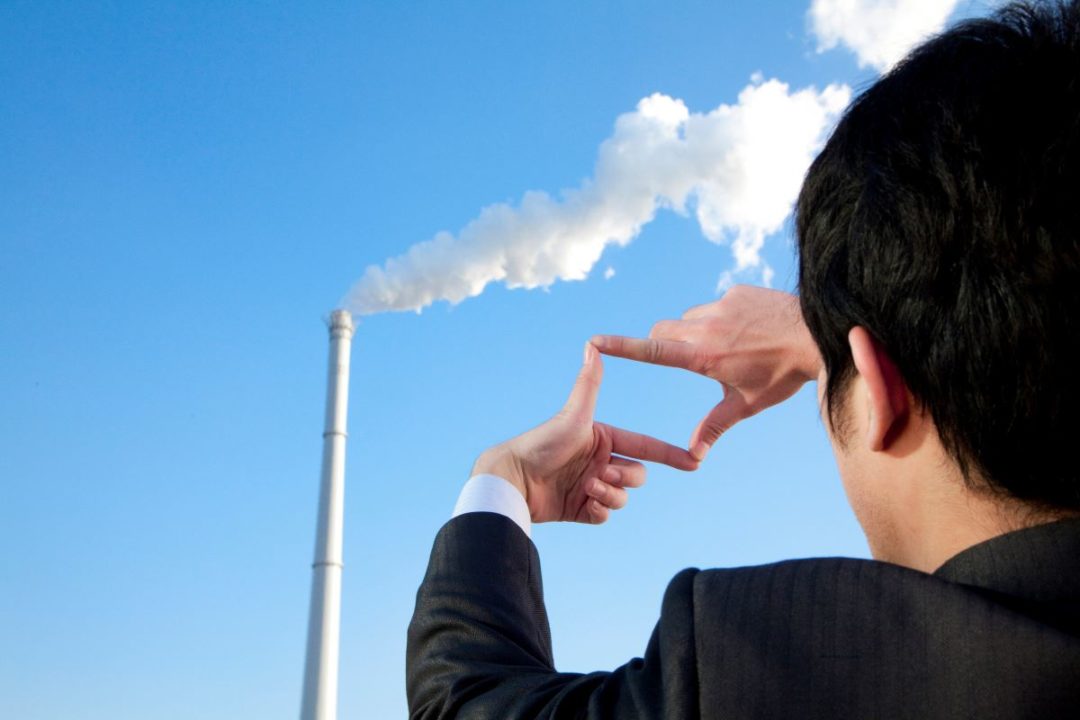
<box><xmin>343</xmin><ymin>78</ymin><xmax>851</xmax><ymax>314</ymax></box>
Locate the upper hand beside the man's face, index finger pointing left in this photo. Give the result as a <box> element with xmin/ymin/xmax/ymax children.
<box><xmin>592</xmin><ymin>285</ymin><xmax>822</xmax><ymax>460</ymax></box>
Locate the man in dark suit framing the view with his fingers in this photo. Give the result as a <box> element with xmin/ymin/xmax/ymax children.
<box><xmin>407</xmin><ymin>0</ymin><xmax>1080</xmax><ymax>719</ymax></box>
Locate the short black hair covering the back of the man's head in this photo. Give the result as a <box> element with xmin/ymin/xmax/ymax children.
<box><xmin>797</xmin><ymin>0</ymin><xmax>1080</xmax><ymax>557</ymax></box>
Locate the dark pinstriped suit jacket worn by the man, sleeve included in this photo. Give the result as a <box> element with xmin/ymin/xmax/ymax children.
<box><xmin>407</xmin><ymin>513</ymin><xmax>1080</xmax><ymax>720</ymax></box>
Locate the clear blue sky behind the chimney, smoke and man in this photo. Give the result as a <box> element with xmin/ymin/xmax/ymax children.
<box><xmin>0</xmin><ymin>0</ymin><xmax>978</xmax><ymax>720</ymax></box>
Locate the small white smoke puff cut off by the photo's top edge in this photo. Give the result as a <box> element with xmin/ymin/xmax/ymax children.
<box><xmin>807</xmin><ymin>0</ymin><xmax>958</xmax><ymax>72</ymax></box>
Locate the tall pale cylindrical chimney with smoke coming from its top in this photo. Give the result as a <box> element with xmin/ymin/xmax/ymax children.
<box><xmin>300</xmin><ymin>310</ymin><xmax>354</xmax><ymax>720</ymax></box>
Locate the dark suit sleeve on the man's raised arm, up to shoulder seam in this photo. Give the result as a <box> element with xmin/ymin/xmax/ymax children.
<box><xmin>406</xmin><ymin>513</ymin><xmax>698</xmax><ymax>720</ymax></box>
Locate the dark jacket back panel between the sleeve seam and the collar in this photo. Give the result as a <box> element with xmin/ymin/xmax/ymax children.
<box><xmin>689</xmin><ymin>558</ymin><xmax>1080</xmax><ymax>718</ymax></box>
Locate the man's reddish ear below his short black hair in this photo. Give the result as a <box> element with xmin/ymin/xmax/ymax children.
<box><xmin>848</xmin><ymin>326</ymin><xmax>909</xmax><ymax>451</ymax></box>
